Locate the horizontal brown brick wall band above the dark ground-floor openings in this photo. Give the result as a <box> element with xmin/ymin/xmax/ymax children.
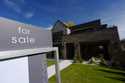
<box><xmin>63</xmin><ymin>28</ymin><xmax>119</xmax><ymax>43</ymax></box>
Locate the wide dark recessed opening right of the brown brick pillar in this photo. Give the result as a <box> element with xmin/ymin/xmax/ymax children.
<box><xmin>80</xmin><ymin>41</ymin><xmax>110</xmax><ymax>60</ymax></box>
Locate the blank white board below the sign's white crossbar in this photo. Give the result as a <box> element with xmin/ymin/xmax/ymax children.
<box><xmin>0</xmin><ymin>57</ymin><xmax>29</xmax><ymax>83</ymax></box>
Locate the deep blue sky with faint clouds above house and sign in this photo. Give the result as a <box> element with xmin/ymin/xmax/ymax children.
<box><xmin>0</xmin><ymin>0</ymin><xmax>125</xmax><ymax>39</ymax></box>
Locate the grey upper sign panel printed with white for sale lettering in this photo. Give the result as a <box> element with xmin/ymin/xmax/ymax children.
<box><xmin>0</xmin><ymin>18</ymin><xmax>52</xmax><ymax>51</ymax></box>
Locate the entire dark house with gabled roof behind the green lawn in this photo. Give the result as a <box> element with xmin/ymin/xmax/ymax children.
<box><xmin>52</xmin><ymin>20</ymin><xmax>120</xmax><ymax>60</ymax></box>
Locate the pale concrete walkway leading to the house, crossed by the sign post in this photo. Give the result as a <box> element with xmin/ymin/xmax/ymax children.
<box><xmin>47</xmin><ymin>60</ymin><xmax>73</xmax><ymax>79</ymax></box>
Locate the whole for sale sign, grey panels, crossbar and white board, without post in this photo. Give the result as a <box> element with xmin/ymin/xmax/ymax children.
<box><xmin>0</xmin><ymin>18</ymin><xmax>53</xmax><ymax>83</ymax></box>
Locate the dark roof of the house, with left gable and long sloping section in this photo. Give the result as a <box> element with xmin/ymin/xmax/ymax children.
<box><xmin>52</xmin><ymin>19</ymin><xmax>107</xmax><ymax>33</ymax></box>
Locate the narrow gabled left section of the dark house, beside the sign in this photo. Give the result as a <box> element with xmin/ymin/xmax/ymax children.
<box><xmin>49</xmin><ymin>21</ymin><xmax>67</xmax><ymax>58</ymax></box>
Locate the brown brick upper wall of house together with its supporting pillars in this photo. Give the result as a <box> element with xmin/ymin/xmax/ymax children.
<box><xmin>63</xmin><ymin>27</ymin><xmax>120</xmax><ymax>58</ymax></box>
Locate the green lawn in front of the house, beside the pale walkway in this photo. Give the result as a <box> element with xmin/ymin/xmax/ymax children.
<box><xmin>49</xmin><ymin>64</ymin><xmax>125</xmax><ymax>83</ymax></box>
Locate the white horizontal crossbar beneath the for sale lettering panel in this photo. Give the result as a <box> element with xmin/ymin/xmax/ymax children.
<box><xmin>0</xmin><ymin>47</ymin><xmax>57</xmax><ymax>60</ymax></box>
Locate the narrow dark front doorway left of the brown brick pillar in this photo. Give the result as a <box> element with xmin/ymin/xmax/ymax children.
<box><xmin>66</xmin><ymin>43</ymin><xmax>75</xmax><ymax>59</ymax></box>
